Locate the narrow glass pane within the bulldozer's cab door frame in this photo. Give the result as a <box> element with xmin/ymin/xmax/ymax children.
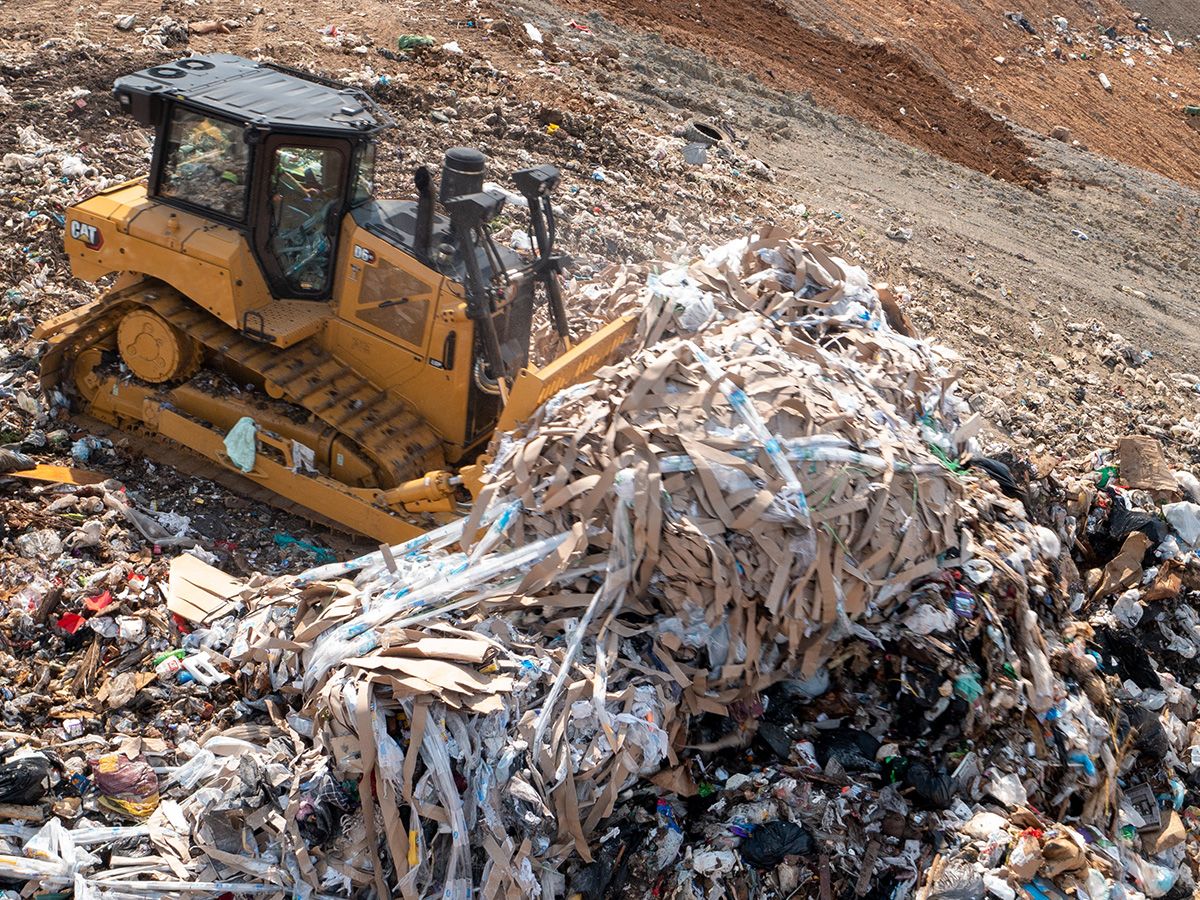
<box><xmin>268</xmin><ymin>145</ymin><xmax>344</xmax><ymax>293</ymax></box>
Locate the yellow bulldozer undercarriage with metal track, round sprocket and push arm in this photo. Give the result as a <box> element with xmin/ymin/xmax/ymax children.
<box><xmin>42</xmin><ymin>281</ymin><xmax>455</xmax><ymax>542</ymax></box>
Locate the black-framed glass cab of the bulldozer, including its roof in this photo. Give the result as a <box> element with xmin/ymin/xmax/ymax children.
<box><xmin>115</xmin><ymin>54</ymin><xmax>381</xmax><ymax>300</ymax></box>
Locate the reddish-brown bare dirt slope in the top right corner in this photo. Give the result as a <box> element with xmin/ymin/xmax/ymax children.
<box><xmin>568</xmin><ymin>0</ymin><xmax>1200</xmax><ymax>185</ymax></box>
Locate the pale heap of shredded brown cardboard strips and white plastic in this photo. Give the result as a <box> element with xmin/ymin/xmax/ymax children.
<box><xmin>2</xmin><ymin>233</ymin><xmax>1060</xmax><ymax>900</ymax></box>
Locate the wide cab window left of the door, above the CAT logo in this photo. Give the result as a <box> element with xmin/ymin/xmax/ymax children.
<box><xmin>158</xmin><ymin>109</ymin><xmax>248</xmax><ymax>218</ymax></box>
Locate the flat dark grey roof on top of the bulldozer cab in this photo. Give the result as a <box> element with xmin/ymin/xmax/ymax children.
<box><xmin>113</xmin><ymin>53</ymin><xmax>391</xmax><ymax>136</ymax></box>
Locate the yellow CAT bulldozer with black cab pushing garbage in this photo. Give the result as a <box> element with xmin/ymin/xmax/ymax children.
<box><xmin>37</xmin><ymin>54</ymin><xmax>632</xmax><ymax>542</ymax></box>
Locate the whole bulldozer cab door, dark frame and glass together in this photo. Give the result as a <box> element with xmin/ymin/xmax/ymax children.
<box><xmin>254</xmin><ymin>134</ymin><xmax>350</xmax><ymax>300</ymax></box>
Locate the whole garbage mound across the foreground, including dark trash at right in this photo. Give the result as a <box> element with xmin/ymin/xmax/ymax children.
<box><xmin>0</xmin><ymin>232</ymin><xmax>1200</xmax><ymax>900</ymax></box>
